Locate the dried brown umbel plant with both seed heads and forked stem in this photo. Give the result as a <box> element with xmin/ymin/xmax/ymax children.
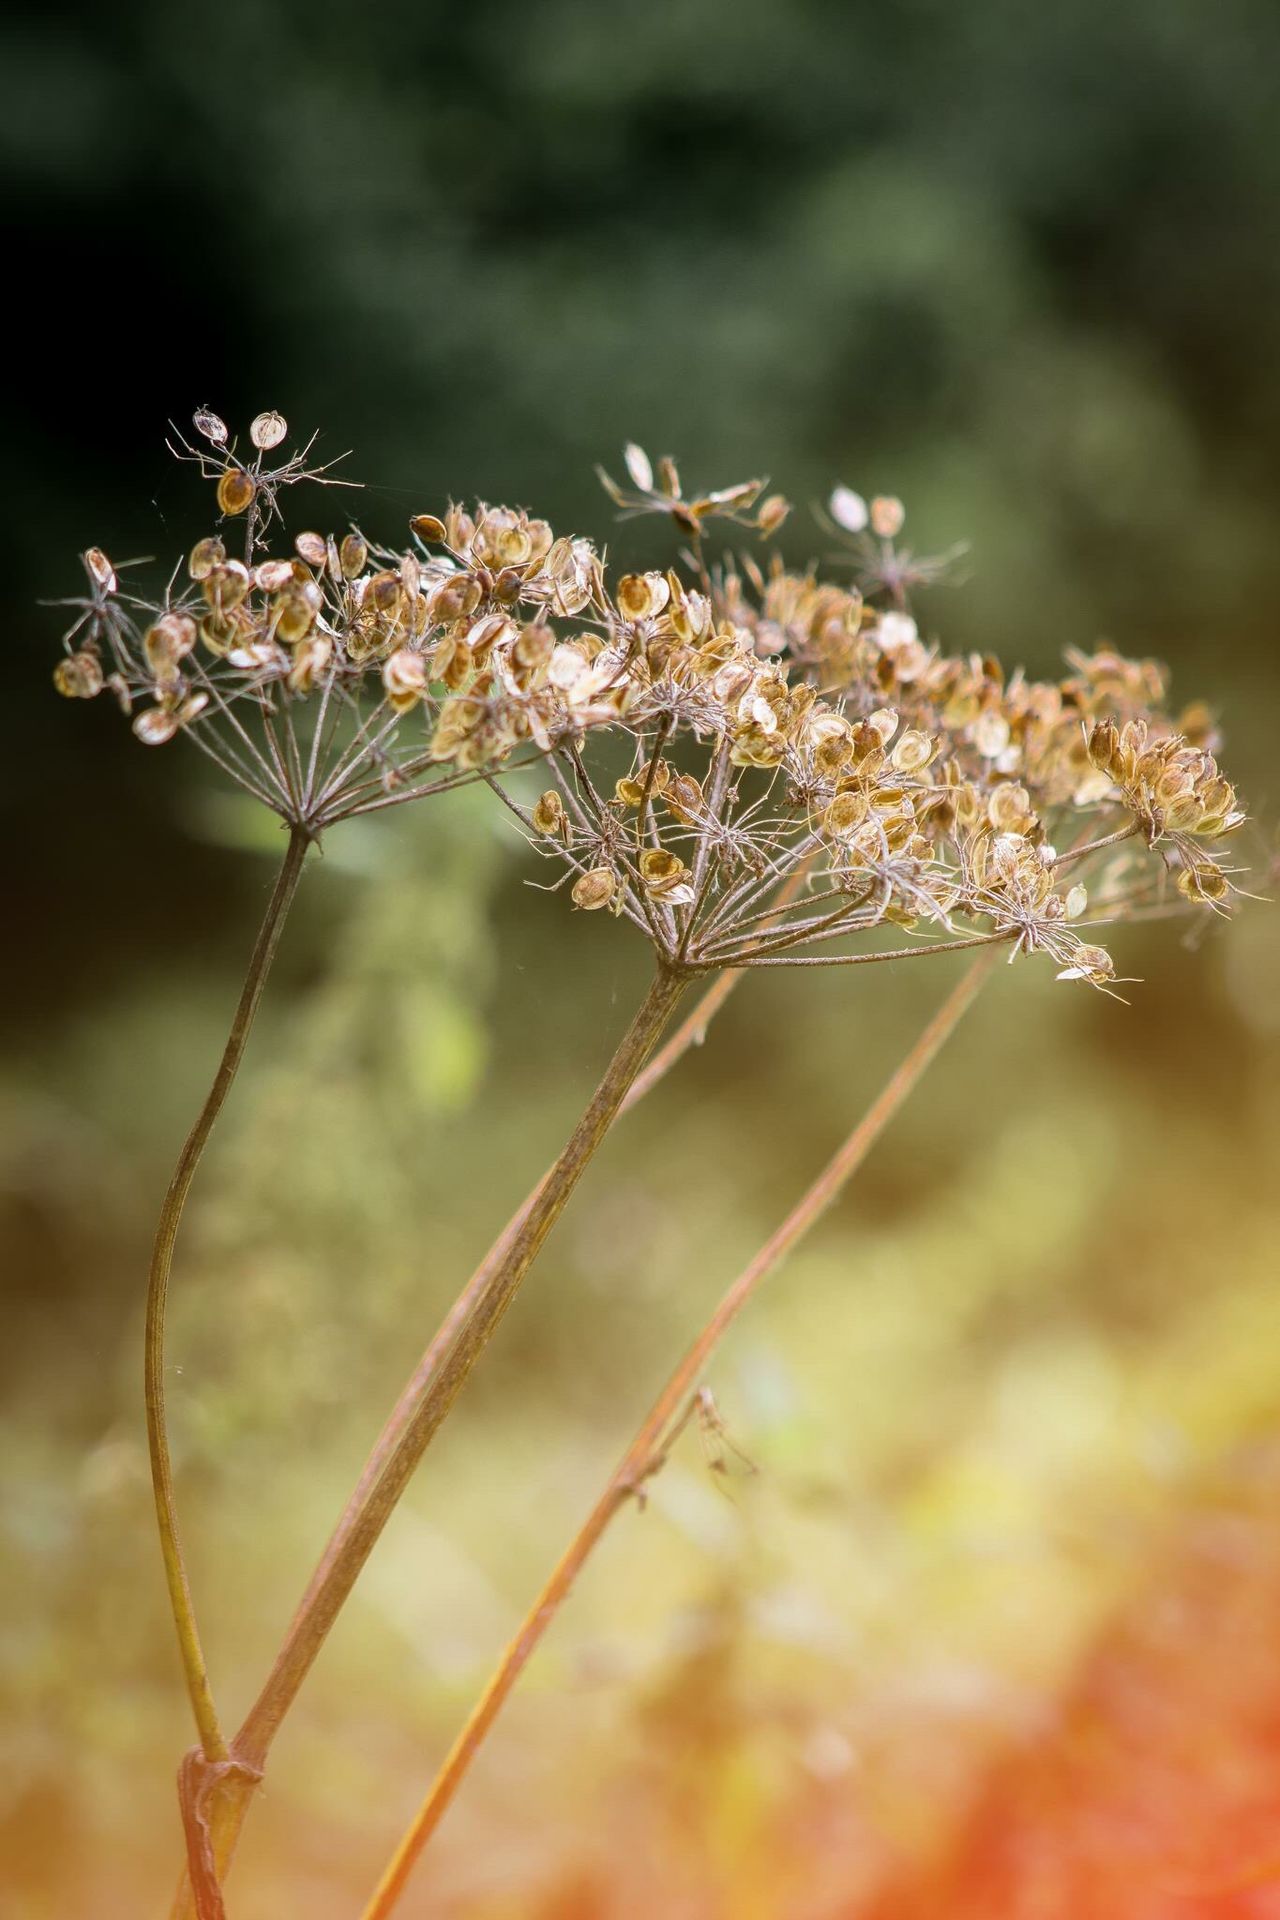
<box><xmin>56</xmin><ymin>428</ymin><xmax>1244</xmax><ymax>1920</ymax></box>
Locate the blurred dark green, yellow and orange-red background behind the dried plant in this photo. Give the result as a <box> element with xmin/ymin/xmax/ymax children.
<box><xmin>0</xmin><ymin>0</ymin><xmax>1280</xmax><ymax>1920</ymax></box>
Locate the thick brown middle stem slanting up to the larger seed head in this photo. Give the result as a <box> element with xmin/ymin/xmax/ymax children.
<box><xmin>175</xmin><ymin>968</ymin><xmax>687</xmax><ymax>1914</ymax></box>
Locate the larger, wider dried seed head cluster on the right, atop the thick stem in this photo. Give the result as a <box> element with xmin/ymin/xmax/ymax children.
<box><xmin>483</xmin><ymin>447</ymin><xmax>1244</xmax><ymax>987</ymax></box>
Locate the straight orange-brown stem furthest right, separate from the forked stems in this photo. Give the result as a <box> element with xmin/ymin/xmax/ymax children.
<box><xmin>361</xmin><ymin>948</ymin><xmax>998</xmax><ymax>1920</ymax></box>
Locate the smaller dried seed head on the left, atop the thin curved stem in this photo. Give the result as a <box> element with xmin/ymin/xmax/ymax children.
<box><xmin>54</xmin><ymin>409</ymin><xmax>628</xmax><ymax>835</ymax></box>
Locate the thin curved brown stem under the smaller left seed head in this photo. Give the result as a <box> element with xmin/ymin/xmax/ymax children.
<box><xmin>142</xmin><ymin>828</ymin><xmax>311</xmax><ymax>1761</ymax></box>
